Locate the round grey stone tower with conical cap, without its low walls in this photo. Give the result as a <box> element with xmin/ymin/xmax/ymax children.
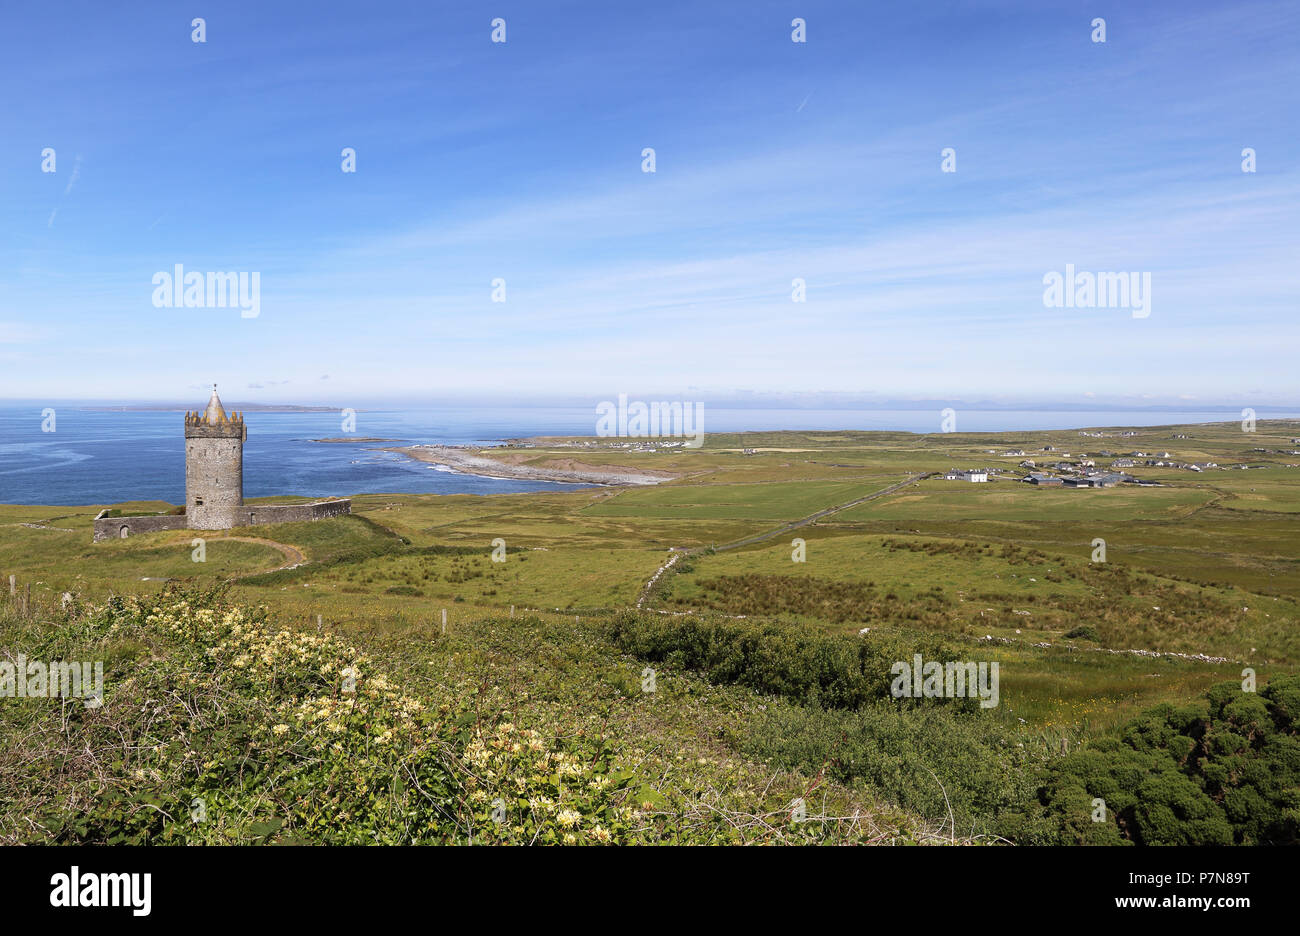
<box><xmin>185</xmin><ymin>384</ymin><xmax>248</xmax><ymax>529</ymax></box>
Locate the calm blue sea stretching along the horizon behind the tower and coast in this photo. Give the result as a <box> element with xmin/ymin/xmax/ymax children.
<box><xmin>0</xmin><ymin>404</ymin><xmax>1295</xmax><ymax>506</ymax></box>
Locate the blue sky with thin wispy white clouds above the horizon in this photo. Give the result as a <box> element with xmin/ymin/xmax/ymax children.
<box><xmin>0</xmin><ymin>0</ymin><xmax>1300</xmax><ymax>406</ymax></box>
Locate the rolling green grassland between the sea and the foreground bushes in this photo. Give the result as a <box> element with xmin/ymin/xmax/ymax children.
<box><xmin>0</xmin><ymin>423</ymin><xmax>1300</xmax><ymax>840</ymax></box>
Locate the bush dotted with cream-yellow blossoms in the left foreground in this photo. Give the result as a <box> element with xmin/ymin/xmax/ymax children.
<box><xmin>12</xmin><ymin>594</ymin><xmax>636</xmax><ymax>844</ymax></box>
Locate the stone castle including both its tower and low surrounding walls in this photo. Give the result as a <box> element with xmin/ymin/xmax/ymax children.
<box><xmin>95</xmin><ymin>385</ymin><xmax>352</xmax><ymax>542</ymax></box>
